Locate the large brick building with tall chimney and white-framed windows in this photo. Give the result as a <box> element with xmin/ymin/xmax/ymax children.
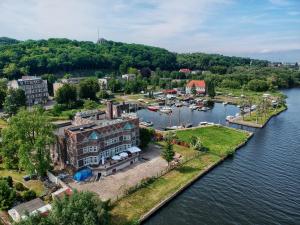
<box><xmin>52</xmin><ymin>102</ymin><xmax>139</xmax><ymax>175</ymax></box>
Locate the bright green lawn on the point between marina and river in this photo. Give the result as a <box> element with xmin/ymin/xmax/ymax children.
<box><xmin>176</xmin><ymin>126</ymin><xmax>248</xmax><ymax>156</ymax></box>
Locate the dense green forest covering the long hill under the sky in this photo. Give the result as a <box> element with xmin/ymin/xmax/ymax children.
<box><xmin>0</xmin><ymin>37</ymin><xmax>268</xmax><ymax>79</ymax></box>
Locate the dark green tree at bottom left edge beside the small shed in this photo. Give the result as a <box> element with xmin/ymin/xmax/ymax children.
<box><xmin>0</xmin><ymin>180</ymin><xmax>16</xmax><ymax>210</ymax></box>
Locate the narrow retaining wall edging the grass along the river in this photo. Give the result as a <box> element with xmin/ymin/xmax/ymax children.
<box><xmin>138</xmin><ymin>131</ymin><xmax>254</xmax><ymax>224</ymax></box>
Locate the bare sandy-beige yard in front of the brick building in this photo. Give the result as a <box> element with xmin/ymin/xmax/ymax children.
<box><xmin>69</xmin><ymin>145</ymin><xmax>168</xmax><ymax>200</ymax></box>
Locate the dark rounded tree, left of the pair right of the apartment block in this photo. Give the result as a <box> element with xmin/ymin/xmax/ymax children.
<box><xmin>55</xmin><ymin>84</ymin><xmax>77</xmax><ymax>106</ymax></box>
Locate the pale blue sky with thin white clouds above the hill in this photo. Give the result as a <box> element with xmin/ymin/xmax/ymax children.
<box><xmin>0</xmin><ymin>0</ymin><xmax>300</xmax><ymax>62</ymax></box>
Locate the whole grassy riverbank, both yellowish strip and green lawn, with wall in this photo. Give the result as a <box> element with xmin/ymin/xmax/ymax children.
<box><xmin>112</xmin><ymin>126</ymin><xmax>252</xmax><ymax>224</ymax></box>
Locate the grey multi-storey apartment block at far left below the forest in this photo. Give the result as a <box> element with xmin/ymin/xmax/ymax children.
<box><xmin>9</xmin><ymin>76</ymin><xmax>49</xmax><ymax>106</ymax></box>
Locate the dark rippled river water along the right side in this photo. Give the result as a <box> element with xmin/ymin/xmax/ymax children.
<box><xmin>144</xmin><ymin>89</ymin><xmax>300</xmax><ymax>225</ymax></box>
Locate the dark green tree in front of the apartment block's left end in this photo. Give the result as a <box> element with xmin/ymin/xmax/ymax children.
<box><xmin>4</xmin><ymin>88</ymin><xmax>26</xmax><ymax>115</ymax></box>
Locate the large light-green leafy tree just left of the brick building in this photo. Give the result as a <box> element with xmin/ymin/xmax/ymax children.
<box><xmin>1</xmin><ymin>107</ymin><xmax>54</xmax><ymax>176</ymax></box>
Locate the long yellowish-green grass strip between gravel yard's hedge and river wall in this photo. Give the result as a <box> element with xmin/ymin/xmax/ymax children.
<box><xmin>112</xmin><ymin>154</ymin><xmax>220</xmax><ymax>225</ymax></box>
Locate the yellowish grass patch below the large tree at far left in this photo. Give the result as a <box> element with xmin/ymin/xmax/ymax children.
<box><xmin>0</xmin><ymin>167</ymin><xmax>45</xmax><ymax>196</ymax></box>
